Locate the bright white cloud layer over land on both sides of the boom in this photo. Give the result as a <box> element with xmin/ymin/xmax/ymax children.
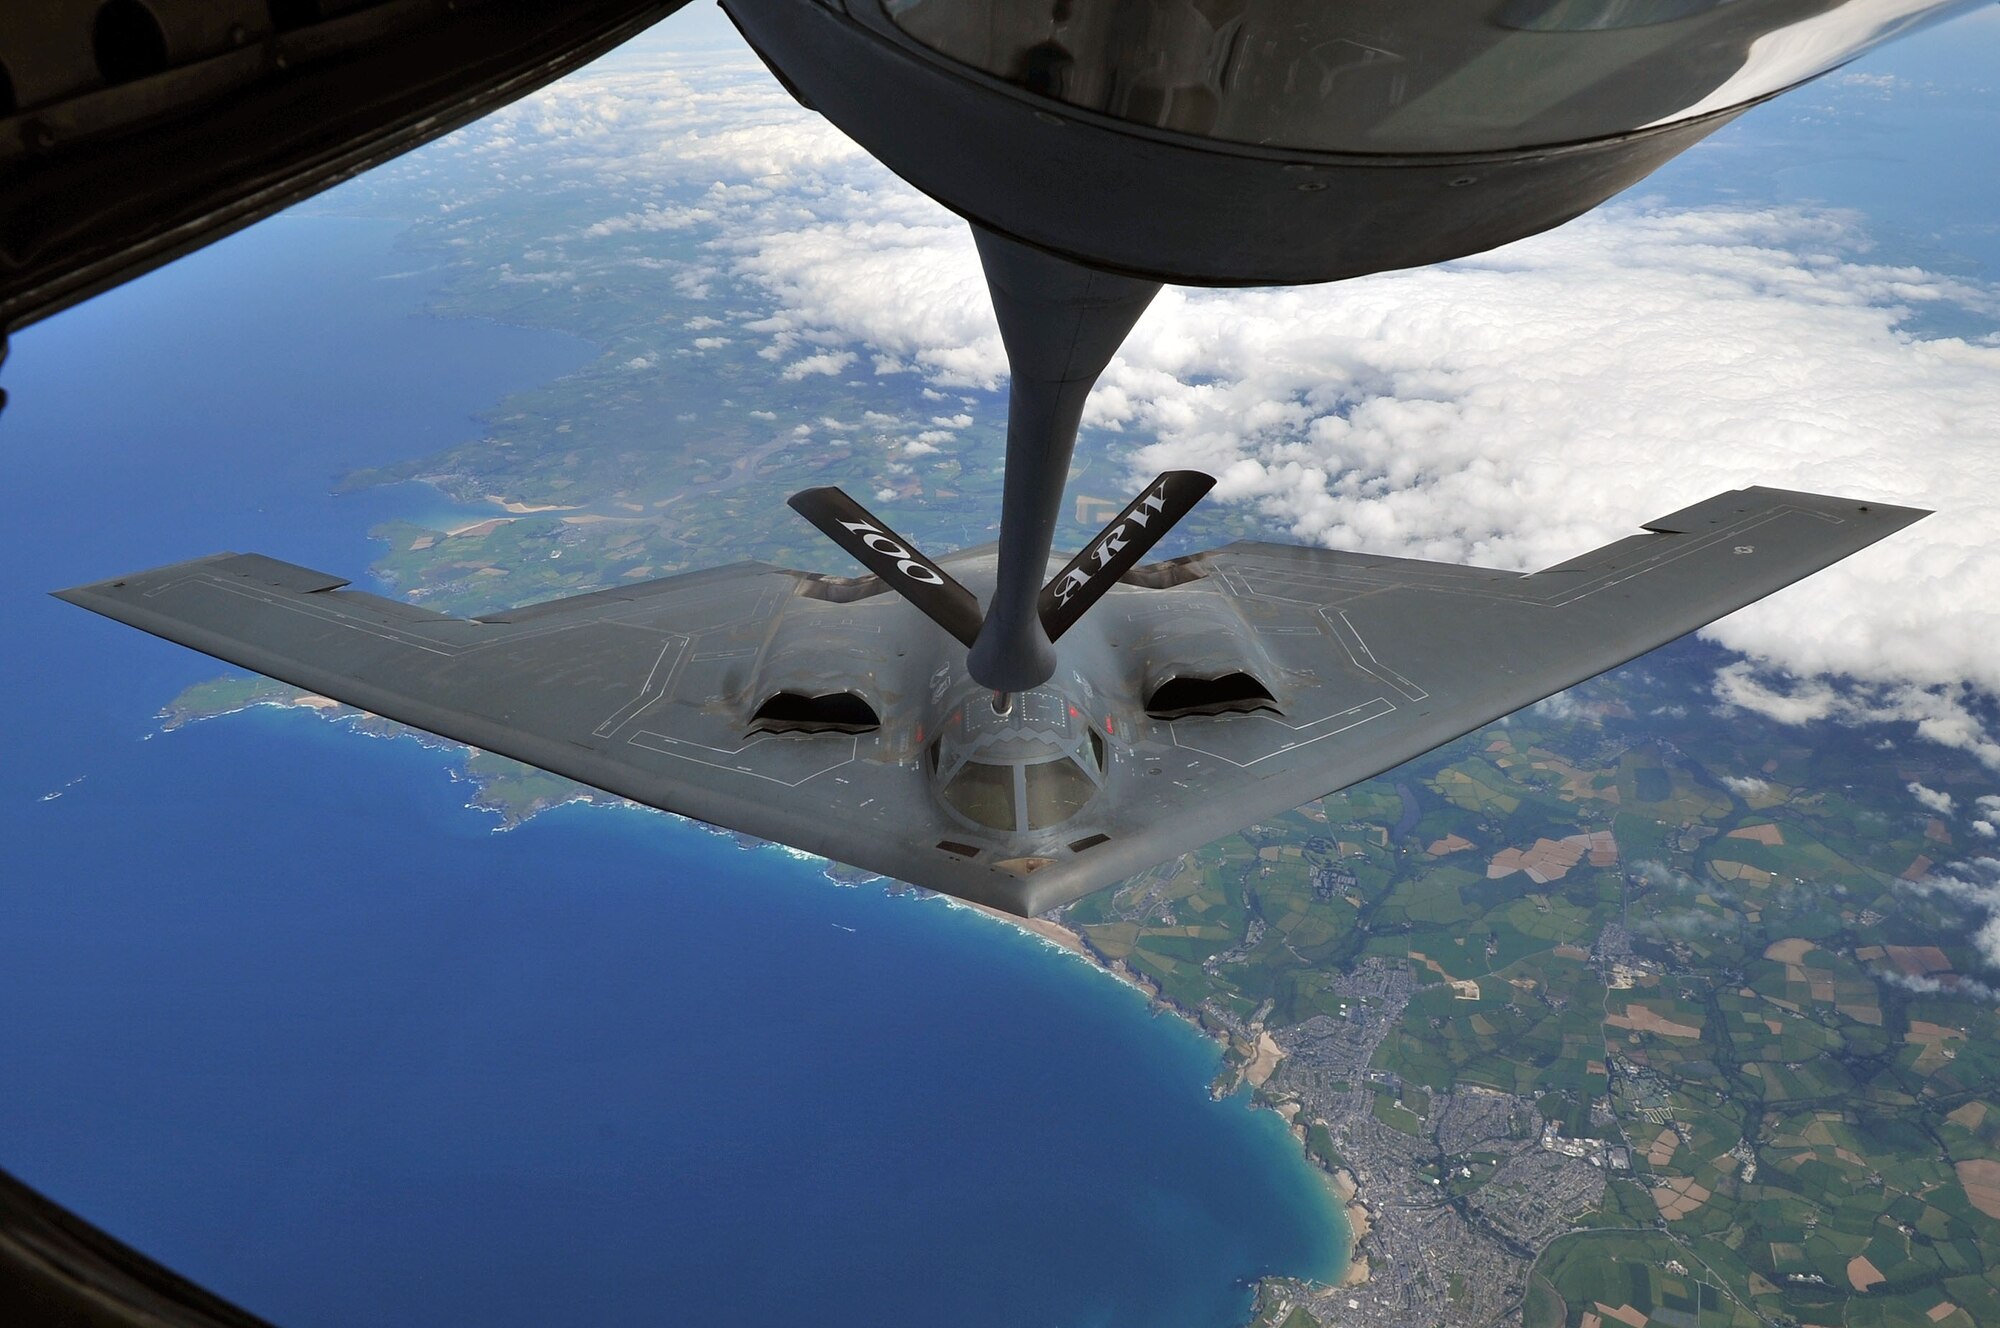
<box><xmin>458</xmin><ymin>56</ymin><xmax>2000</xmax><ymax>768</ymax></box>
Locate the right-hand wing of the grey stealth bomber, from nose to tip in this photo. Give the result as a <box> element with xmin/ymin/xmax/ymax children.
<box><xmin>1028</xmin><ymin>488</ymin><xmax>1926</xmax><ymax>912</ymax></box>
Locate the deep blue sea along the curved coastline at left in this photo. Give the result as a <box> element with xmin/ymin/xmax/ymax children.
<box><xmin>0</xmin><ymin>216</ymin><xmax>1346</xmax><ymax>1328</ymax></box>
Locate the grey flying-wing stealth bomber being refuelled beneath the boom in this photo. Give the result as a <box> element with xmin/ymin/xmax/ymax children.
<box><xmin>62</xmin><ymin>472</ymin><xmax>1920</xmax><ymax>914</ymax></box>
